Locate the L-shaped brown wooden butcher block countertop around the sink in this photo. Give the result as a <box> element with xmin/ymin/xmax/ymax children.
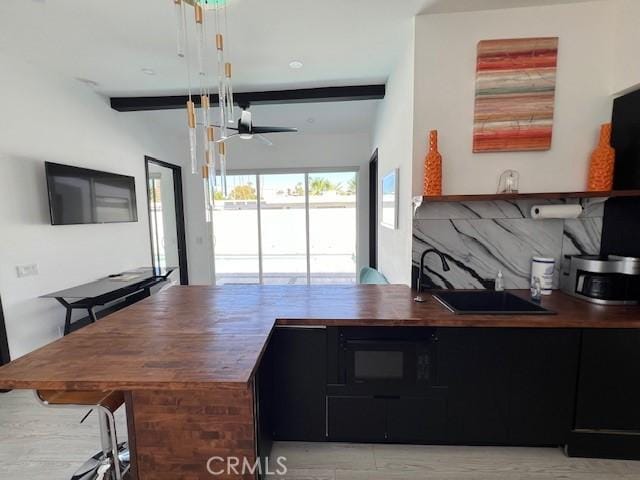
<box><xmin>0</xmin><ymin>285</ymin><xmax>640</xmax><ymax>390</ymax></box>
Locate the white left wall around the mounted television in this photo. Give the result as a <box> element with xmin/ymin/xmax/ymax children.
<box><xmin>0</xmin><ymin>55</ymin><xmax>182</xmax><ymax>358</ymax></box>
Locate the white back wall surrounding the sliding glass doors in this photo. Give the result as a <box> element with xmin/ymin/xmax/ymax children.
<box><xmin>159</xmin><ymin>127</ymin><xmax>371</xmax><ymax>285</ymax></box>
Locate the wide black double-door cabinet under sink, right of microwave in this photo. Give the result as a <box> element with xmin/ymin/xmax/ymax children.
<box><xmin>438</xmin><ymin>328</ymin><xmax>580</xmax><ymax>446</ymax></box>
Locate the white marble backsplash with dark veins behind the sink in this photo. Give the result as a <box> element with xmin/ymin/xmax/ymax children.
<box><xmin>412</xmin><ymin>198</ymin><xmax>606</xmax><ymax>288</ymax></box>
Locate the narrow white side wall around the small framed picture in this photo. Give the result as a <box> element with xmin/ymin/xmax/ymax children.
<box><xmin>373</xmin><ymin>21</ymin><xmax>414</xmax><ymax>284</ymax></box>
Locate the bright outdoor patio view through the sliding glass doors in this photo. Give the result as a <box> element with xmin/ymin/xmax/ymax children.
<box><xmin>213</xmin><ymin>171</ymin><xmax>357</xmax><ymax>285</ymax></box>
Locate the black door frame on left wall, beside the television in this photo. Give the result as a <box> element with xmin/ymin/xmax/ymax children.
<box><xmin>144</xmin><ymin>155</ymin><xmax>189</xmax><ymax>285</ymax></box>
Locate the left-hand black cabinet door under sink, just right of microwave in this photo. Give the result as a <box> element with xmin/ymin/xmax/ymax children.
<box><xmin>438</xmin><ymin>328</ymin><xmax>510</xmax><ymax>444</ymax></box>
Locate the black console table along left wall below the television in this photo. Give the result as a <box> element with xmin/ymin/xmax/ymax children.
<box><xmin>40</xmin><ymin>267</ymin><xmax>176</xmax><ymax>335</ymax></box>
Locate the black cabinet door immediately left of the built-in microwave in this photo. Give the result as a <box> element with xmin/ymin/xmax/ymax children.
<box><xmin>269</xmin><ymin>328</ymin><xmax>327</xmax><ymax>441</ymax></box>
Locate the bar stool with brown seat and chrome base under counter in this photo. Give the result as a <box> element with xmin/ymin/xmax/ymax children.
<box><xmin>34</xmin><ymin>390</ymin><xmax>130</xmax><ymax>480</ymax></box>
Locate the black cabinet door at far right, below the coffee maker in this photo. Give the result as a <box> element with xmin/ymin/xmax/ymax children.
<box><xmin>576</xmin><ymin>329</ymin><xmax>640</xmax><ymax>432</ymax></box>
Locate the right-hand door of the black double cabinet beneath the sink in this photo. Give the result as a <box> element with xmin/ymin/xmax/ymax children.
<box><xmin>508</xmin><ymin>329</ymin><xmax>580</xmax><ymax>445</ymax></box>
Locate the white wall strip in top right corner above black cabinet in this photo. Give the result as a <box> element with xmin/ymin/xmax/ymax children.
<box><xmin>611</xmin><ymin>0</ymin><xmax>640</xmax><ymax>94</ymax></box>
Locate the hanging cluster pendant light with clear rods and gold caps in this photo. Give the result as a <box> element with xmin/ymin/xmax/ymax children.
<box><xmin>172</xmin><ymin>0</ymin><xmax>235</xmax><ymax>216</ymax></box>
